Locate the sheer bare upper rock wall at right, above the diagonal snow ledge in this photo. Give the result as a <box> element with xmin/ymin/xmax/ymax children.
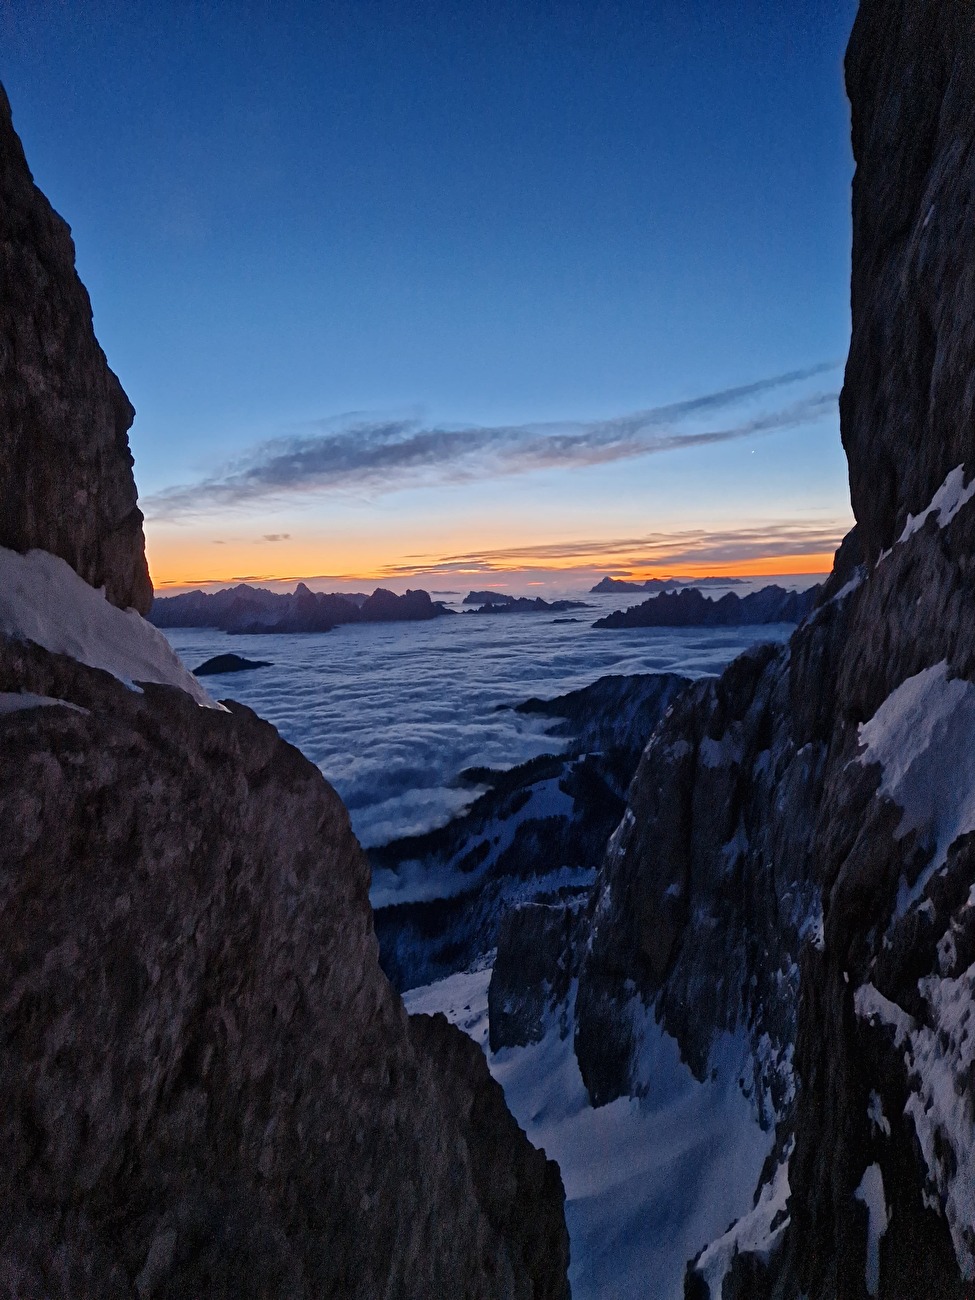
<box><xmin>841</xmin><ymin>0</ymin><xmax>975</xmax><ymax>560</ymax></box>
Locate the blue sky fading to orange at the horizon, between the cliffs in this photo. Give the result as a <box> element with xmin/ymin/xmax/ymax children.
<box><xmin>0</xmin><ymin>0</ymin><xmax>855</xmax><ymax>594</ymax></box>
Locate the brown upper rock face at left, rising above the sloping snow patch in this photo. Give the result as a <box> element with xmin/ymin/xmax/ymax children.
<box><xmin>0</xmin><ymin>87</ymin><xmax>152</xmax><ymax>614</ymax></box>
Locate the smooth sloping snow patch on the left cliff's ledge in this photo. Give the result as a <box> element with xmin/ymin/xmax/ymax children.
<box><xmin>0</xmin><ymin>547</ymin><xmax>221</xmax><ymax>709</ymax></box>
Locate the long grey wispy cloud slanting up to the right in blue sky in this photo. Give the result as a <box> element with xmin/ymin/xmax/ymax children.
<box><xmin>143</xmin><ymin>363</ymin><xmax>837</xmax><ymax>517</ymax></box>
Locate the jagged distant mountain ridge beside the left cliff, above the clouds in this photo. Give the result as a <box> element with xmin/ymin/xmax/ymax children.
<box><xmin>148</xmin><ymin>582</ymin><xmax>452</xmax><ymax>636</ymax></box>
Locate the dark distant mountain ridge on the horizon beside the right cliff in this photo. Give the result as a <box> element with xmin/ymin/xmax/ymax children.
<box><xmin>593</xmin><ymin>585</ymin><xmax>819</xmax><ymax>628</ymax></box>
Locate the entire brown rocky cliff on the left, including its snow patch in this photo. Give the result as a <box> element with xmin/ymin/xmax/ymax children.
<box><xmin>0</xmin><ymin>86</ymin><xmax>568</xmax><ymax>1300</ymax></box>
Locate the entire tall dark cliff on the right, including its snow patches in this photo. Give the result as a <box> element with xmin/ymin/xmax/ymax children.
<box><xmin>499</xmin><ymin>0</ymin><xmax>975</xmax><ymax>1300</ymax></box>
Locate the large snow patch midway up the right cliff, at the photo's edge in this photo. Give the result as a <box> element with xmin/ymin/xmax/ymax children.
<box><xmin>859</xmin><ymin>660</ymin><xmax>975</xmax><ymax>915</ymax></box>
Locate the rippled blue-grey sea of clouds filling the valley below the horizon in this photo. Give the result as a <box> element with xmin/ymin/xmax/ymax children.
<box><xmin>166</xmin><ymin>589</ymin><xmax>792</xmax><ymax>848</ymax></box>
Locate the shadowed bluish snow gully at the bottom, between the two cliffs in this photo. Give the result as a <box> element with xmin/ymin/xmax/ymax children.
<box><xmin>404</xmin><ymin>970</ymin><xmax>769</xmax><ymax>1300</ymax></box>
